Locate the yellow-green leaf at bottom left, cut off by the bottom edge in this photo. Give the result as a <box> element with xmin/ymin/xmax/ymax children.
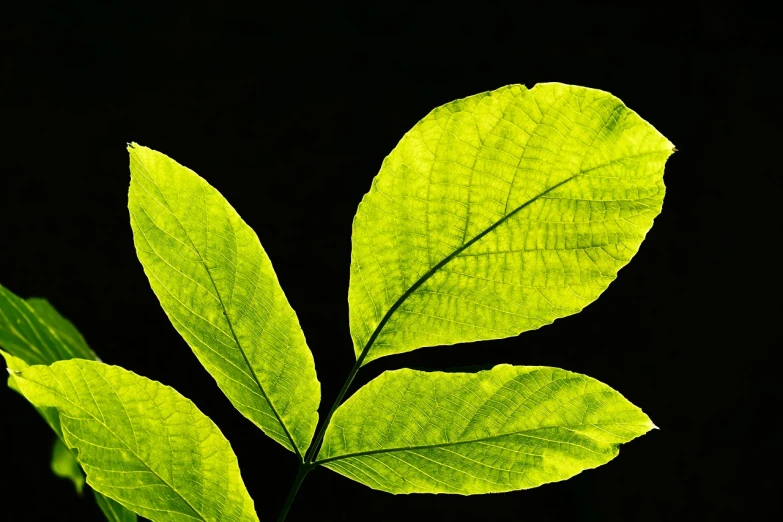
<box><xmin>16</xmin><ymin>359</ymin><xmax>258</xmax><ymax>522</ymax></box>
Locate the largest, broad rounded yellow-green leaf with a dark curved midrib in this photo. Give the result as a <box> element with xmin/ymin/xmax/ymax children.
<box><xmin>348</xmin><ymin>83</ymin><xmax>673</xmax><ymax>363</ymax></box>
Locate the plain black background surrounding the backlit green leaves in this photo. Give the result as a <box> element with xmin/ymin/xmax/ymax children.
<box><xmin>0</xmin><ymin>1</ymin><xmax>783</xmax><ymax>521</ymax></box>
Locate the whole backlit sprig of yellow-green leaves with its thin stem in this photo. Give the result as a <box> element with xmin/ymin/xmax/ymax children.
<box><xmin>0</xmin><ymin>83</ymin><xmax>674</xmax><ymax>522</ymax></box>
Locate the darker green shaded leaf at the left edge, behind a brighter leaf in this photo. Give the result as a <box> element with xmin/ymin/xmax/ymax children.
<box><xmin>0</xmin><ymin>285</ymin><xmax>96</xmax><ymax>364</ymax></box>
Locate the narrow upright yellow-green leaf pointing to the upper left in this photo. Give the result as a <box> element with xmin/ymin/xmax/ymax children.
<box><xmin>128</xmin><ymin>143</ymin><xmax>321</xmax><ymax>459</ymax></box>
